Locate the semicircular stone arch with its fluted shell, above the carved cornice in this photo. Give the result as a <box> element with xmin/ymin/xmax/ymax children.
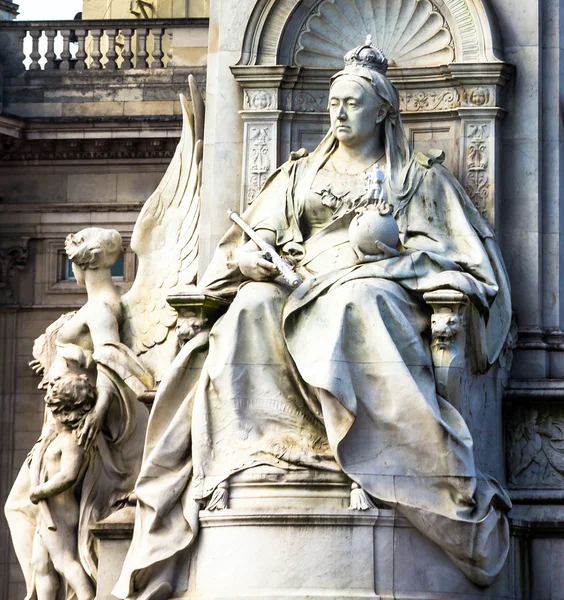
<box><xmin>239</xmin><ymin>0</ymin><xmax>503</xmax><ymax>68</ymax></box>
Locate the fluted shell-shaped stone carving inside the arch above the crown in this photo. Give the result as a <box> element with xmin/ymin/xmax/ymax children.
<box><xmin>294</xmin><ymin>0</ymin><xmax>454</xmax><ymax>67</ymax></box>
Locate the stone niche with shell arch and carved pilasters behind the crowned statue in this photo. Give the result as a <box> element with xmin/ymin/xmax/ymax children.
<box><xmin>232</xmin><ymin>0</ymin><xmax>513</xmax><ymax>229</ymax></box>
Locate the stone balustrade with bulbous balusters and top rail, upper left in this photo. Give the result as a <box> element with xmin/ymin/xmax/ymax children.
<box><xmin>0</xmin><ymin>18</ymin><xmax>208</xmax><ymax>71</ymax></box>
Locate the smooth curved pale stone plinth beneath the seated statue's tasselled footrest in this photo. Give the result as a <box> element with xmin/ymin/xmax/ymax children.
<box><xmin>184</xmin><ymin>509</ymin><xmax>527</xmax><ymax>600</ymax></box>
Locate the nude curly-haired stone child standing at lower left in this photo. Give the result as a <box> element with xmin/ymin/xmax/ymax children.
<box><xmin>30</xmin><ymin>374</ymin><xmax>96</xmax><ymax>600</ymax></box>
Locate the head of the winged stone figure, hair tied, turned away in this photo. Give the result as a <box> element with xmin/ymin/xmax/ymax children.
<box><xmin>65</xmin><ymin>227</ymin><xmax>123</xmax><ymax>285</ymax></box>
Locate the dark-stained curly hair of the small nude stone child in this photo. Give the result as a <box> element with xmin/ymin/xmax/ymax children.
<box><xmin>45</xmin><ymin>373</ymin><xmax>96</xmax><ymax>429</ymax></box>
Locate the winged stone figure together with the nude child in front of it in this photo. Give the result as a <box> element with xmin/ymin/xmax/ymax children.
<box><xmin>6</xmin><ymin>76</ymin><xmax>204</xmax><ymax>600</ymax></box>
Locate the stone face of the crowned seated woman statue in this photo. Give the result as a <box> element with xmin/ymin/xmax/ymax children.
<box><xmin>329</xmin><ymin>77</ymin><xmax>382</xmax><ymax>147</ymax></box>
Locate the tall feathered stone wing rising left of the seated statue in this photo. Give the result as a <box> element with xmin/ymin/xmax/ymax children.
<box><xmin>121</xmin><ymin>75</ymin><xmax>205</xmax><ymax>381</ymax></box>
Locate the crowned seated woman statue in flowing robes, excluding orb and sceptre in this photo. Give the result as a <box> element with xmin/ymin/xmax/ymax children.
<box><xmin>114</xmin><ymin>42</ymin><xmax>511</xmax><ymax>599</ymax></box>
